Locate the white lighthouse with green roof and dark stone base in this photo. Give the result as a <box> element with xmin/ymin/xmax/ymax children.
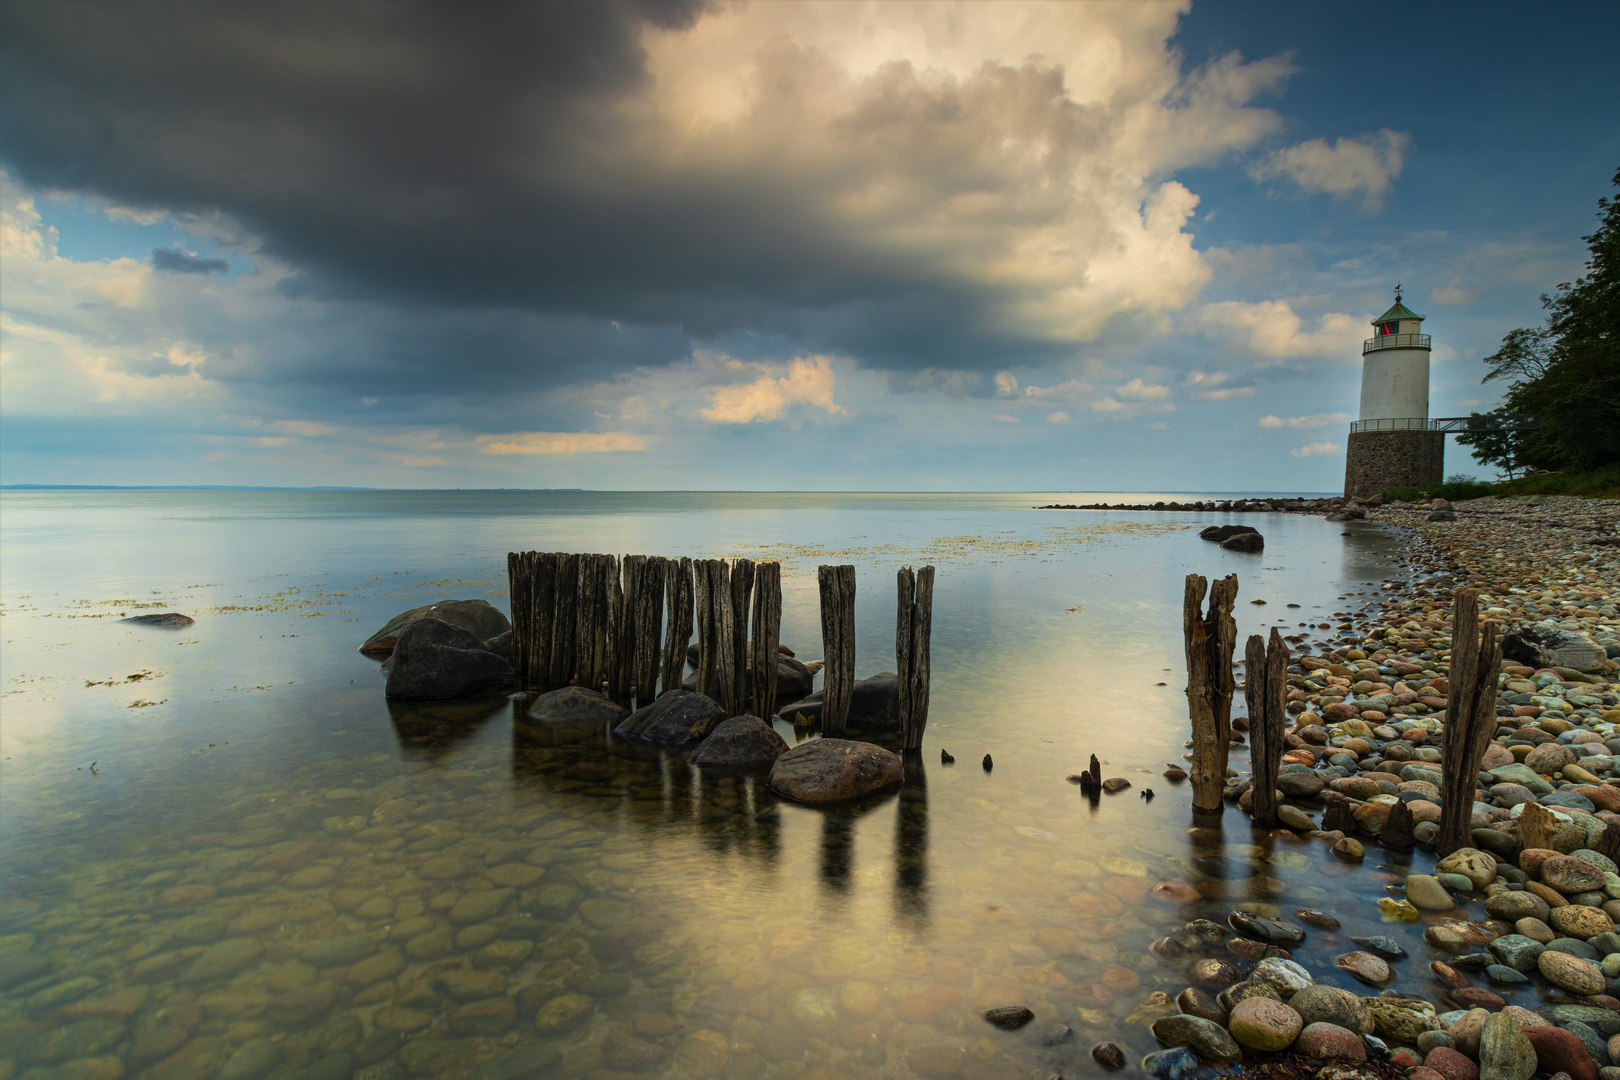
<box><xmin>1345</xmin><ymin>285</ymin><xmax>1445</xmax><ymax>499</ymax></box>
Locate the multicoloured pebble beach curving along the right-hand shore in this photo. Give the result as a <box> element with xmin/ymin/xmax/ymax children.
<box><xmin>1114</xmin><ymin>497</ymin><xmax>1620</xmax><ymax>1080</ymax></box>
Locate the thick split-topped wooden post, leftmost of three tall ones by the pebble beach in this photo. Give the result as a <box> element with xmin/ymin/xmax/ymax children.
<box><xmin>1181</xmin><ymin>573</ymin><xmax>1238</xmax><ymax>810</ymax></box>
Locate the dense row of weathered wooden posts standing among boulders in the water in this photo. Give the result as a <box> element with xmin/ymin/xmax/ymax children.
<box><xmin>507</xmin><ymin>551</ymin><xmax>933</xmax><ymax>750</ymax></box>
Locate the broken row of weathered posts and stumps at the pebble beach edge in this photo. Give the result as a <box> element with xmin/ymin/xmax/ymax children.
<box><xmin>1183</xmin><ymin>573</ymin><xmax>1522</xmax><ymax>857</ymax></box>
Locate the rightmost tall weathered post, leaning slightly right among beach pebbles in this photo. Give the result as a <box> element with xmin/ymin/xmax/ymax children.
<box><xmin>1434</xmin><ymin>588</ymin><xmax>1502</xmax><ymax>858</ymax></box>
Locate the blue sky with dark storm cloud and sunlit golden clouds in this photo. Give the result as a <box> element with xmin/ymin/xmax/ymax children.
<box><xmin>0</xmin><ymin>0</ymin><xmax>1620</xmax><ymax>492</ymax></box>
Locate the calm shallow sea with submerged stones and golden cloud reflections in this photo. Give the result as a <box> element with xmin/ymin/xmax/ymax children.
<box><xmin>0</xmin><ymin>492</ymin><xmax>1421</xmax><ymax>1080</ymax></box>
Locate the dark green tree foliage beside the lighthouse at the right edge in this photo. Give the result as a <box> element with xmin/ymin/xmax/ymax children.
<box><xmin>1456</xmin><ymin>170</ymin><xmax>1620</xmax><ymax>478</ymax></box>
